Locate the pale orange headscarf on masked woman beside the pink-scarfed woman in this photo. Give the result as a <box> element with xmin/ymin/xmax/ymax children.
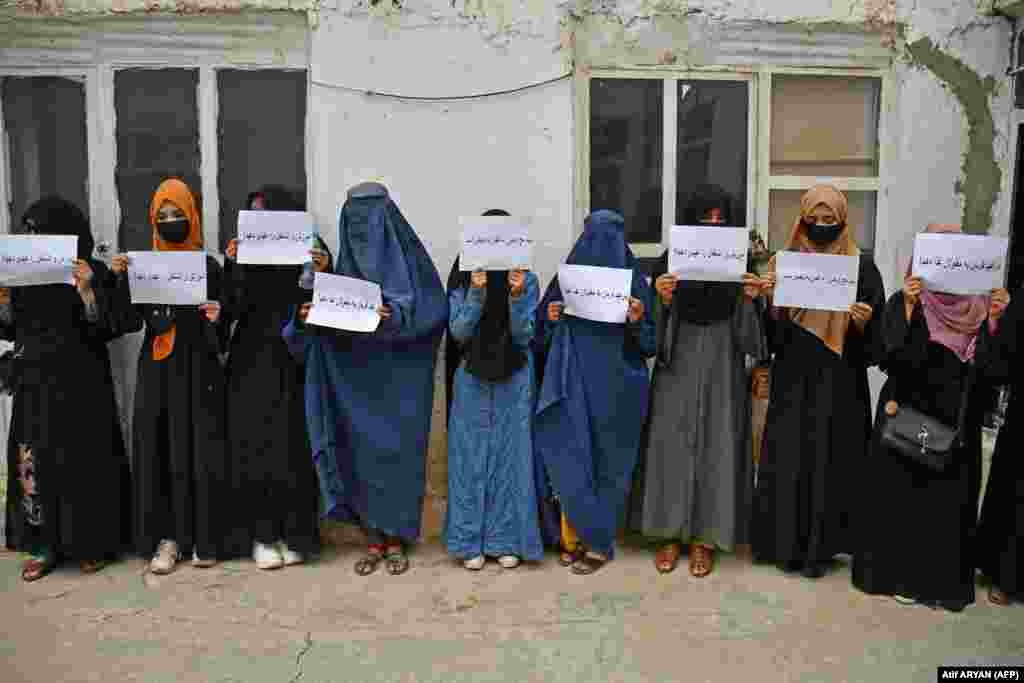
<box><xmin>769</xmin><ymin>185</ymin><xmax>860</xmax><ymax>355</ymax></box>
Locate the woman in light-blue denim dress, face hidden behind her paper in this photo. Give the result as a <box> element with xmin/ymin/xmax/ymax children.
<box><xmin>444</xmin><ymin>209</ymin><xmax>544</xmax><ymax>570</ymax></box>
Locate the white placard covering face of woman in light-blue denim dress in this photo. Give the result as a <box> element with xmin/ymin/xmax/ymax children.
<box><xmin>459</xmin><ymin>216</ymin><xmax>534</xmax><ymax>270</ymax></box>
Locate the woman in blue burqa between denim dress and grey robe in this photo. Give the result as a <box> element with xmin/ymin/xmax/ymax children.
<box><xmin>534</xmin><ymin>210</ymin><xmax>655</xmax><ymax>574</ymax></box>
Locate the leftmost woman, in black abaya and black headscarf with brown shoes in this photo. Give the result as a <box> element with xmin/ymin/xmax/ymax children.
<box><xmin>0</xmin><ymin>197</ymin><xmax>129</xmax><ymax>582</ymax></box>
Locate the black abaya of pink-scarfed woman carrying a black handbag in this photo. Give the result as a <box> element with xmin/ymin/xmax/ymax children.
<box><xmin>851</xmin><ymin>292</ymin><xmax>989</xmax><ymax>610</ymax></box>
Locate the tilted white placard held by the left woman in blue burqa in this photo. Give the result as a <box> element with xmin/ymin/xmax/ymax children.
<box><xmin>306</xmin><ymin>272</ymin><xmax>383</xmax><ymax>332</ymax></box>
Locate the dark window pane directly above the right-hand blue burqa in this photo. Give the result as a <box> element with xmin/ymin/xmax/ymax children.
<box><xmin>590</xmin><ymin>79</ymin><xmax>665</xmax><ymax>243</ymax></box>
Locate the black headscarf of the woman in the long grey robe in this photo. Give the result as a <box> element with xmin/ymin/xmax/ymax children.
<box><xmin>654</xmin><ymin>185</ymin><xmax>742</xmax><ymax>325</ymax></box>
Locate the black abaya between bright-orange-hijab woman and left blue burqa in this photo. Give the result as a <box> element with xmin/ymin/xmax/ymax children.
<box><xmin>225</xmin><ymin>261</ymin><xmax>319</xmax><ymax>557</ymax></box>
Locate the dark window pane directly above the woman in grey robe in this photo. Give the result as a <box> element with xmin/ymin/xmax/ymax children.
<box><xmin>676</xmin><ymin>81</ymin><xmax>750</xmax><ymax>227</ymax></box>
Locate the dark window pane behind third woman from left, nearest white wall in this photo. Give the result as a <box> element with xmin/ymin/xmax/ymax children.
<box><xmin>217</xmin><ymin>71</ymin><xmax>306</xmax><ymax>251</ymax></box>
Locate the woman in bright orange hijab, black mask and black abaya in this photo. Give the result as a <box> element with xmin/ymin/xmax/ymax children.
<box><xmin>112</xmin><ymin>178</ymin><xmax>227</xmax><ymax>573</ymax></box>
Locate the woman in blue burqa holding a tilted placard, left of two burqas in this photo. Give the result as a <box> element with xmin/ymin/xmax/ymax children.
<box><xmin>284</xmin><ymin>182</ymin><xmax>447</xmax><ymax>575</ymax></box>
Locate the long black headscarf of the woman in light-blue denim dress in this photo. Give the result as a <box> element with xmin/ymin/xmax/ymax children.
<box><xmin>444</xmin><ymin>209</ymin><xmax>527</xmax><ymax>419</ymax></box>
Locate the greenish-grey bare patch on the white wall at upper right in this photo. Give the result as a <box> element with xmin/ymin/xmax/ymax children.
<box><xmin>906</xmin><ymin>37</ymin><xmax>1002</xmax><ymax>233</ymax></box>
